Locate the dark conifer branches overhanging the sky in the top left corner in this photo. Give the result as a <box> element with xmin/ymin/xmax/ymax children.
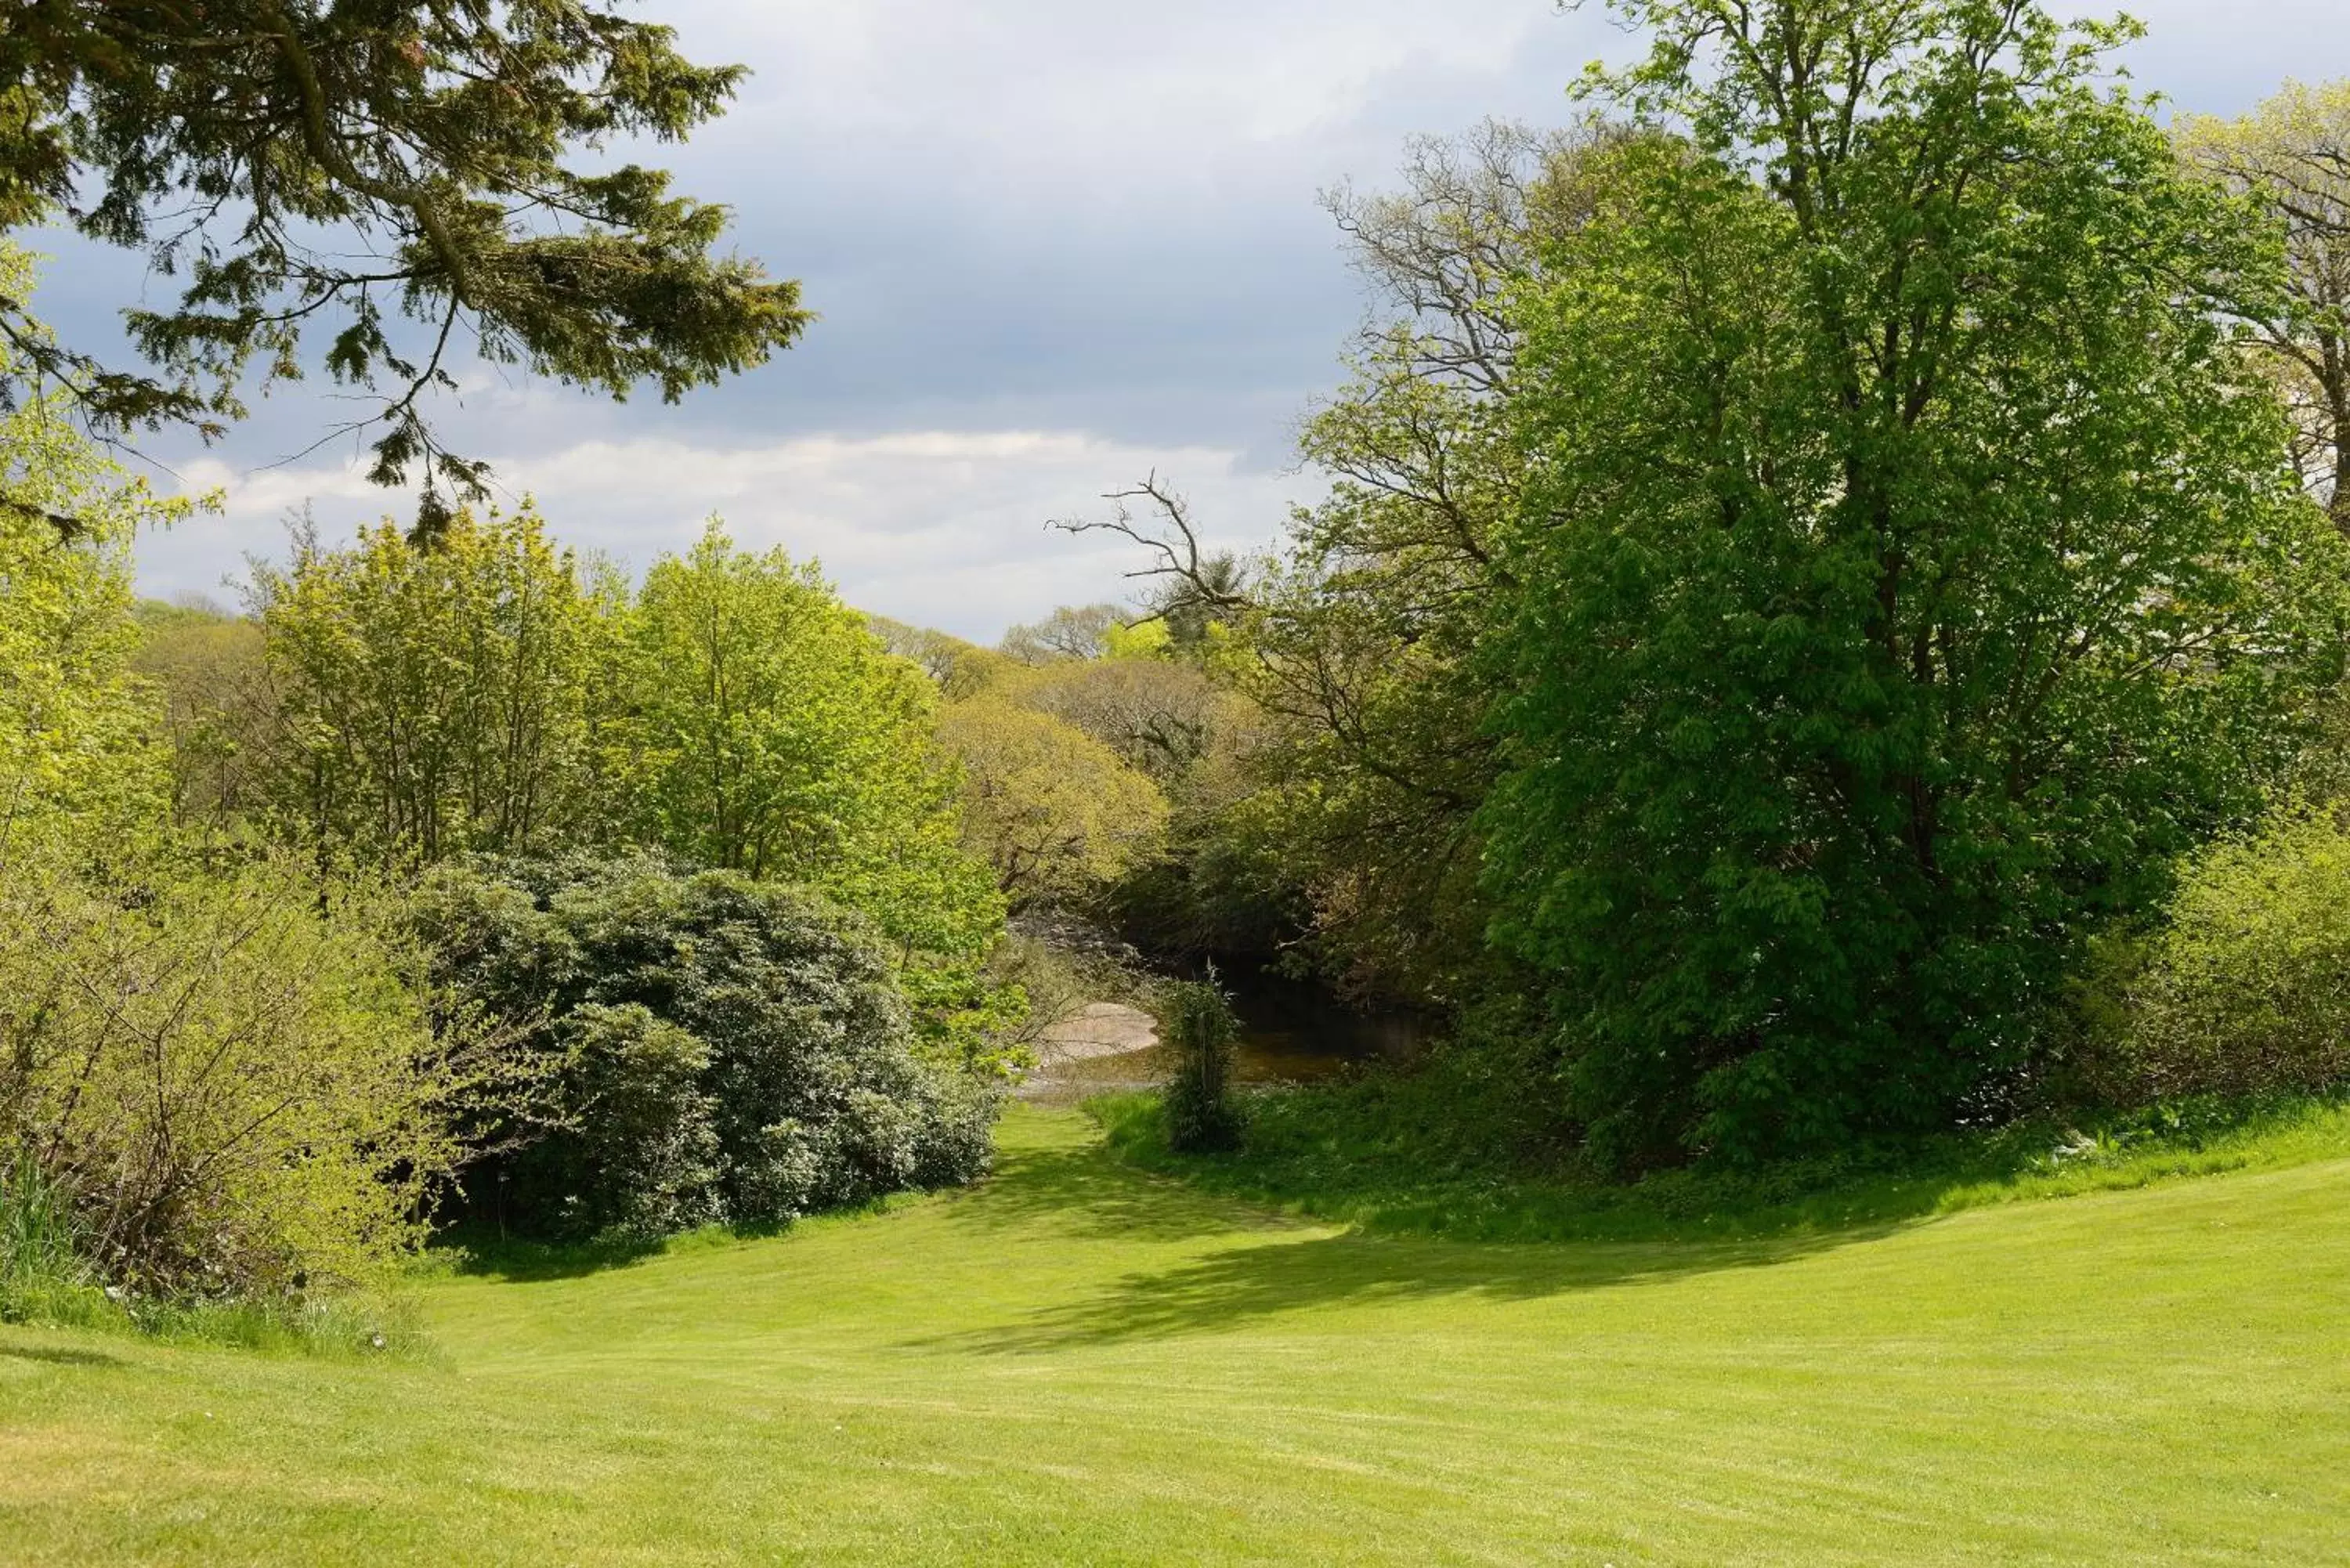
<box><xmin>0</xmin><ymin>0</ymin><xmax>808</xmax><ymax>531</ymax></box>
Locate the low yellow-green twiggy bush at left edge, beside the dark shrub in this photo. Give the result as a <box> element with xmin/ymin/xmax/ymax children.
<box><xmin>0</xmin><ymin>851</ymin><xmax>465</xmax><ymax>1298</ymax></box>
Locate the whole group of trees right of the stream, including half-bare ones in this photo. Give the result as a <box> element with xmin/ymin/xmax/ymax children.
<box><xmin>987</xmin><ymin>0</ymin><xmax>2350</xmax><ymax>1171</ymax></box>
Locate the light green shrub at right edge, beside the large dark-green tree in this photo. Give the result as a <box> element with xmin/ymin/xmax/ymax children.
<box><xmin>2082</xmin><ymin>814</ymin><xmax>2350</xmax><ymax>1100</ymax></box>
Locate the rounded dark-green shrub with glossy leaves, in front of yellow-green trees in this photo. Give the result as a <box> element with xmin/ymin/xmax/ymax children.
<box><xmin>418</xmin><ymin>858</ymin><xmax>996</xmax><ymax>1237</ymax></box>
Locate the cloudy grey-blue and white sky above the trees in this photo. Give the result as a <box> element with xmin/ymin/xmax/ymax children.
<box><xmin>42</xmin><ymin>0</ymin><xmax>2350</xmax><ymax>641</ymax></box>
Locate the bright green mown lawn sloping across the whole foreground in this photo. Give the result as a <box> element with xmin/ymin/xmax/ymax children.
<box><xmin>0</xmin><ymin>1110</ymin><xmax>2350</xmax><ymax>1568</ymax></box>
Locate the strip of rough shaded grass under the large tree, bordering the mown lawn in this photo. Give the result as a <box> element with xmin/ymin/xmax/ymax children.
<box><xmin>1086</xmin><ymin>1053</ymin><xmax>2350</xmax><ymax>1241</ymax></box>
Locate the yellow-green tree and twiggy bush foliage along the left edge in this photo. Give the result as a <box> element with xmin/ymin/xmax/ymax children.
<box><xmin>0</xmin><ymin>305</ymin><xmax>477</xmax><ymax>1295</ymax></box>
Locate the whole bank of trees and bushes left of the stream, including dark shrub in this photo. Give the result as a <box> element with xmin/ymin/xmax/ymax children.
<box><xmin>0</xmin><ymin>230</ymin><xmax>1001</xmax><ymax>1326</ymax></box>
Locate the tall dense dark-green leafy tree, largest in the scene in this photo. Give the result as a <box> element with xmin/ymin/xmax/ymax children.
<box><xmin>1485</xmin><ymin>0</ymin><xmax>2341</xmax><ymax>1162</ymax></box>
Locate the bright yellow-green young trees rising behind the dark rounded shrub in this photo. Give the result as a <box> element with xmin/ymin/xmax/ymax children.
<box><xmin>245</xmin><ymin>508</ymin><xmax>1001</xmax><ymax>964</ymax></box>
